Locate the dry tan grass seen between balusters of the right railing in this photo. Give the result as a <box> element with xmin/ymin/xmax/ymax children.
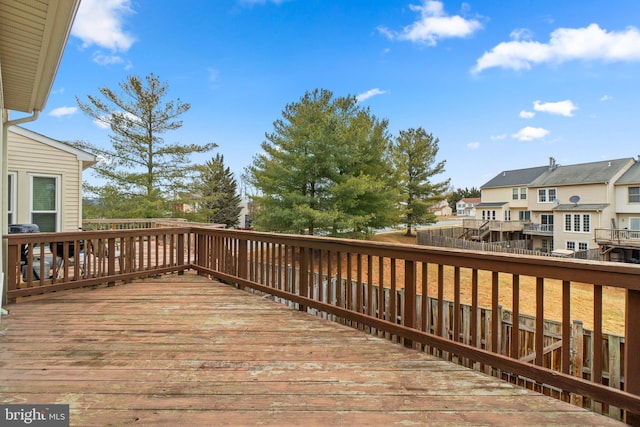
<box><xmin>370</xmin><ymin>231</ymin><xmax>625</xmax><ymax>335</ymax></box>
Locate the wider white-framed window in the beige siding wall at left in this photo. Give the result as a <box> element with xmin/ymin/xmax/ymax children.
<box><xmin>31</xmin><ymin>175</ymin><xmax>60</xmax><ymax>232</ymax></box>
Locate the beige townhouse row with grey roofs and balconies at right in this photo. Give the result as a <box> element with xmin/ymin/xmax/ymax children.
<box><xmin>467</xmin><ymin>158</ymin><xmax>640</xmax><ymax>259</ymax></box>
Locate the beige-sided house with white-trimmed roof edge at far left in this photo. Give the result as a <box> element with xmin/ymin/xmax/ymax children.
<box><xmin>7</xmin><ymin>126</ymin><xmax>96</xmax><ymax>232</ymax></box>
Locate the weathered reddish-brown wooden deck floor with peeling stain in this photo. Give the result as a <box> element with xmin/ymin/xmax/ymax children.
<box><xmin>0</xmin><ymin>274</ymin><xmax>621</xmax><ymax>426</ymax></box>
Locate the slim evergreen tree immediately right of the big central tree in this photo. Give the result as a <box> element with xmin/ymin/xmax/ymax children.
<box><xmin>391</xmin><ymin>128</ymin><xmax>450</xmax><ymax>236</ymax></box>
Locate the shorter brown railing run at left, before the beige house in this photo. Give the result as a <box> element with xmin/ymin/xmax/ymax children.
<box><xmin>4</xmin><ymin>227</ymin><xmax>194</xmax><ymax>302</ymax></box>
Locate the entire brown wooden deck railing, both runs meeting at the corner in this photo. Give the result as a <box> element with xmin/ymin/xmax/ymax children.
<box><xmin>5</xmin><ymin>227</ymin><xmax>640</xmax><ymax>424</ymax></box>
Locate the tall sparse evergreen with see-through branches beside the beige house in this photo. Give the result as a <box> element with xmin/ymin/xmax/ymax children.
<box><xmin>75</xmin><ymin>73</ymin><xmax>216</xmax><ymax>218</ymax></box>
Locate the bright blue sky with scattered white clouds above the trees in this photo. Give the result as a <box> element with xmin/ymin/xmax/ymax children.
<box><xmin>17</xmin><ymin>0</ymin><xmax>640</xmax><ymax>188</ymax></box>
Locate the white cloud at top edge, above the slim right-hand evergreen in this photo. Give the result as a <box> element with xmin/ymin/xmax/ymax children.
<box><xmin>378</xmin><ymin>0</ymin><xmax>482</xmax><ymax>46</ymax></box>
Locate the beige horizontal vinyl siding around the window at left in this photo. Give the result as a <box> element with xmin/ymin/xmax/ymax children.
<box><xmin>7</xmin><ymin>130</ymin><xmax>82</xmax><ymax>231</ymax></box>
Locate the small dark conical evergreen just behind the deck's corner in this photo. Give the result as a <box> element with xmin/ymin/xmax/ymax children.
<box><xmin>193</xmin><ymin>154</ymin><xmax>241</xmax><ymax>227</ymax></box>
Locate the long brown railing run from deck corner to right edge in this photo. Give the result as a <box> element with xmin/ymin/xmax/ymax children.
<box><xmin>194</xmin><ymin>230</ymin><xmax>640</xmax><ymax>424</ymax></box>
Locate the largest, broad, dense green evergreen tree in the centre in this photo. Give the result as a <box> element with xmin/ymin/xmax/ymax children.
<box><xmin>245</xmin><ymin>89</ymin><xmax>397</xmax><ymax>237</ymax></box>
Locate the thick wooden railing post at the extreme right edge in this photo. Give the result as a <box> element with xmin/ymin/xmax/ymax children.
<box><xmin>624</xmin><ymin>289</ymin><xmax>640</xmax><ymax>426</ymax></box>
